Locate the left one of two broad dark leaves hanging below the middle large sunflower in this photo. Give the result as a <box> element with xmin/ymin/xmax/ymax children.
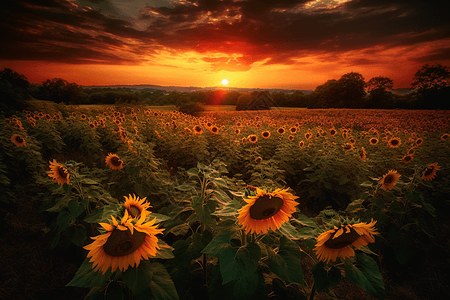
<box><xmin>219</xmin><ymin>243</ymin><xmax>261</xmax><ymax>284</ymax></box>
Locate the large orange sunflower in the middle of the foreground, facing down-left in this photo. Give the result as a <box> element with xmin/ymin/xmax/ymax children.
<box><xmin>238</xmin><ymin>188</ymin><xmax>298</xmax><ymax>233</ymax></box>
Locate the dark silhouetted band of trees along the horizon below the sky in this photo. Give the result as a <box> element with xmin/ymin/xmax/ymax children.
<box><xmin>0</xmin><ymin>64</ymin><xmax>450</xmax><ymax>112</ymax></box>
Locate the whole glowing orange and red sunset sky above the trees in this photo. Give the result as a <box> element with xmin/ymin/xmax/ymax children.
<box><xmin>0</xmin><ymin>0</ymin><xmax>450</xmax><ymax>90</ymax></box>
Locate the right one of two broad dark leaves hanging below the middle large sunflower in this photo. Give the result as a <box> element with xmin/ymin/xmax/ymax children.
<box><xmin>268</xmin><ymin>236</ymin><xmax>303</xmax><ymax>284</ymax></box>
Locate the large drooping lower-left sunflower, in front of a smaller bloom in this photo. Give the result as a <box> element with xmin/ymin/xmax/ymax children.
<box><xmin>83</xmin><ymin>211</ymin><xmax>164</xmax><ymax>274</ymax></box>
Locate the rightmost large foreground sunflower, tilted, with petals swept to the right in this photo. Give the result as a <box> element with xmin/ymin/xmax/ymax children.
<box><xmin>313</xmin><ymin>219</ymin><xmax>378</xmax><ymax>263</ymax></box>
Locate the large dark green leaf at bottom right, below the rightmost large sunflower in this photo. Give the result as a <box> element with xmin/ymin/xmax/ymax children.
<box><xmin>344</xmin><ymin>253</ymin><xmax>385</xmax><ymax>299</ymax></box>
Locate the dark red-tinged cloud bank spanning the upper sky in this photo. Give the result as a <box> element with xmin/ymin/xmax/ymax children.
<box><xmin>0</xmin><ymin>0</ymin><xmax>450</xmax><ymax>70</ymax></box>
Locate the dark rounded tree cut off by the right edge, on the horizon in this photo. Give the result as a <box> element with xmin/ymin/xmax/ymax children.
<box><xmin>411</xmin><ymin>64</ymin><xmax>450</xmax><ymax>109</ymax></box>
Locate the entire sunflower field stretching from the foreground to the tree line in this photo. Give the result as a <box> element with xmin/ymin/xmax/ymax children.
<box><xmin>0</xmin><ymin>105</ymin><xmax>450</xmax><ymax>300</ymax></box>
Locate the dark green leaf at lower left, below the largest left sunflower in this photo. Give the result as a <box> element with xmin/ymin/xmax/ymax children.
<box><xmin>66</xmin><ymin>258</ymin><xmax>112</xmax><ymax>288</ymax></box>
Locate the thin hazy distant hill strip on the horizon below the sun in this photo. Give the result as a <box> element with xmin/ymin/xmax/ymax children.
<box><xmin>83</xmin><ymin>84</ymin><xmax>312</xmax><ymax>94</ymax></box>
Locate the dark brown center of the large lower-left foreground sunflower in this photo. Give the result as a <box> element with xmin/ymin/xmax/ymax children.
<box><xmin>103</xmin><ymin>229</ymin><xmax>145</xmax><ymax>256</ymax></box>
